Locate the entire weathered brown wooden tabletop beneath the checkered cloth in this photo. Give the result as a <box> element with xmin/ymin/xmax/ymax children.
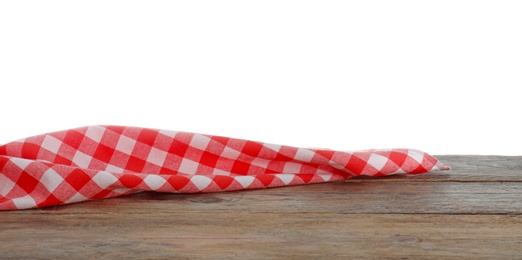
<box><xmin>0</xmin><ymin>156</ymin><xmax>522</xmax><ymax>259</ymax></box>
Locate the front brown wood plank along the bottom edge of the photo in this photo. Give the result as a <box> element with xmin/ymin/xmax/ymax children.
<box><xmin>0</xmin><ymin>212</ymin><xmax>522</xmax><ymax>259</ymax></box>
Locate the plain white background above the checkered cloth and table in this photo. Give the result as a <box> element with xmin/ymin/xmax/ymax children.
<box><xmin>0</xmin><ymin>0</ymin><xmax>522</xmax><ymax>155</ymax></box>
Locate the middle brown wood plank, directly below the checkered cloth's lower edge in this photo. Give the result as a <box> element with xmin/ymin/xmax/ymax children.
<box><xmin>6</xmin><ymin>182</ymin><xmax>522</xmax><ymax>215</ymax></box>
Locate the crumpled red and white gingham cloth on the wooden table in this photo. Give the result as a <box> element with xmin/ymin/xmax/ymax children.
<box><xmin>0</xmin><ymin>126</ymin><xmax>449</xmax><ymax>210</ymax></box>
